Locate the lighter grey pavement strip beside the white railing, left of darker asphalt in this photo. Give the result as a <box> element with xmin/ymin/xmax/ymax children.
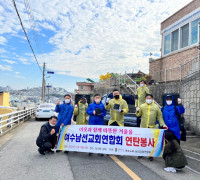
<box><xmin>0</xmin><ymin>120</ymin><xmax>73</xmax><ymax>180</ymax></box>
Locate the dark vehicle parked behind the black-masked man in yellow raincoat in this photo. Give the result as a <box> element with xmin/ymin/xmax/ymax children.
<box><xmin>102</xmin><ymin>93</ymin><xmax>137</xmax><ymax>127</ymax></box>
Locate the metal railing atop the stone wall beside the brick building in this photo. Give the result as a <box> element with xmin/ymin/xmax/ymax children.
<box><xmin>153</xmin><ymin>56</ymin><xmax>200</xmax><ymax>82</ymax></box>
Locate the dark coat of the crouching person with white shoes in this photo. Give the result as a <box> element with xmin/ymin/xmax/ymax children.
<box><xmin>163</xmin><ymin>140</ymin><xmax>187</xmax><ymax>168</ymax></box>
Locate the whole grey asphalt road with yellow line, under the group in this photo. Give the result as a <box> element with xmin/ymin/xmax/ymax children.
<box><xmin>0</xmin><ymin>119</ymin><xmax>200</xmax><ymax>180</ymax></box>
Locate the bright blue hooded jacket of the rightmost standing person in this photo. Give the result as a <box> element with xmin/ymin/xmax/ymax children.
<box><xmin>162</xmin><ymin>95</ymin><xmax>185</xmax><ymax>139</ymax></box>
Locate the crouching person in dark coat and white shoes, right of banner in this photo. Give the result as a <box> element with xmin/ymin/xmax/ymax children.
<box><xmin>163</xmin><ymin>132</ymin><xmax>187</xmax><ymax>173</ymax></box>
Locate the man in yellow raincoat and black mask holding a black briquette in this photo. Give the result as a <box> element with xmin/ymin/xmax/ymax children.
<box><xmin>105</xmin><ymin>89</ymin><xmax>129</xmax><ymax>126</ymax></box>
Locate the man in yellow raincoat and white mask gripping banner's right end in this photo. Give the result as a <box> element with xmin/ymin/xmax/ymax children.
<box><xmin>136</xmin><ymin>94</ymin><xmax>167</xmax><ymax>161</ymax></box>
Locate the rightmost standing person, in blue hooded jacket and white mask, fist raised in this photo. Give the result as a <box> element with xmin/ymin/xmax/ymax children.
<box><xmin>161</xmin><ymin>95</ymin><xmax>185</xmax><ymax>144</ymax></box>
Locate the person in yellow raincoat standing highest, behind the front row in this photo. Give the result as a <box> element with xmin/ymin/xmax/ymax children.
<box><xmin>135</xmin><ymin>80</ymin><xmax>149</xmax><ymax>127</ymax></box>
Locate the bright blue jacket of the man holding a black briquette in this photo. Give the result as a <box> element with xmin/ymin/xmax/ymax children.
<box><xmin>87</xmin><ymin>101</ymin><xmax>106</xmax><ymax>125</ymax></box>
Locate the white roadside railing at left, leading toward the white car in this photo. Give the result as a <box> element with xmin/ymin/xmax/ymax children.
<box><xmin>0</xmin><ymin>107</ymin><xmax>36</xmax><ymax>134</ymax></box>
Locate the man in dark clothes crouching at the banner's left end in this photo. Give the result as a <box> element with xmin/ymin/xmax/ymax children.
<box><xmin>36</xmin><ymin>116</ymin><xmax>57</xmax><ymax>155</ymax></box>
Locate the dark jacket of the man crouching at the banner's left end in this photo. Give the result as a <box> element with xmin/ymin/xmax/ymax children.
<box><xmin>36</xmin><ymin>122</ymin><xmax>57</xmax><ymax>147</ymax></box>
